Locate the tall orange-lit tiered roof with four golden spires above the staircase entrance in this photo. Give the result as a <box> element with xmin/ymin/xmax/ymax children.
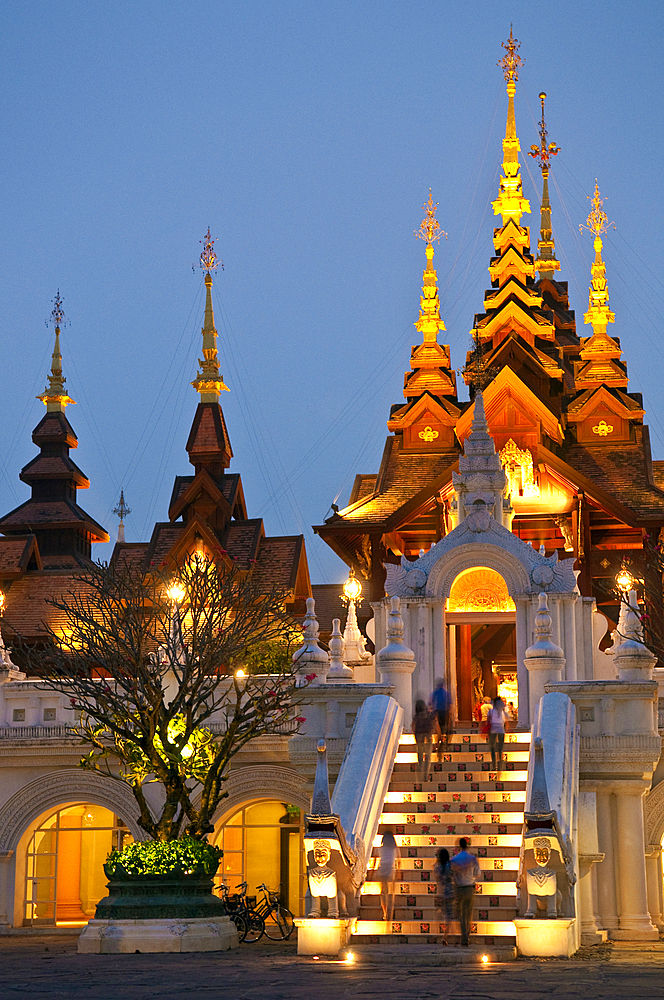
<box><xmin>315</xmin><ymin>33</ymin><xmax>664</xmax><ymax>603</ymax></box>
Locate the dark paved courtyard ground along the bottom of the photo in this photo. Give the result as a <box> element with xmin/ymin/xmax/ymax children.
<box><xmin>0</xmin><ymin>935</ymin><xmax>664</xmax><ymax>1000</ymax></box>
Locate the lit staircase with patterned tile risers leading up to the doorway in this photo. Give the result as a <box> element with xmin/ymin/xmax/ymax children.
<box><xmin>353</xmin><ymin>730</ymin><xmax>530</xmax><ymax>948</ymax></box>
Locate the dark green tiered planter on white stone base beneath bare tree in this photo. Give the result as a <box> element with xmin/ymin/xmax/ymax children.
<box><xmin>78</xmin><ymin>868</ymin><xmax>239</xmax><ymax>954</ymax></box>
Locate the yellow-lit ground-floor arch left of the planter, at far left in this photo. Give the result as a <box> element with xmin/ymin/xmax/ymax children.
<box><xmin>21</xmin><ymin>802</ymin><xmax>133</xmax><ymax>927</ymax></box>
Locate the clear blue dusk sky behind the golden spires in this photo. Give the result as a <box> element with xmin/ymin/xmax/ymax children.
<box><xmin>0</xmin><ymin>0</ymin><xmax>664</xmax><ymax>582</ymax></box>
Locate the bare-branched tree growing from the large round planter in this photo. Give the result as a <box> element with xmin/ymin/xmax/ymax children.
<box><xmin>13</xmin><ymin>557</ymin><xmax>303</xmax><ymax>841</ymax></box>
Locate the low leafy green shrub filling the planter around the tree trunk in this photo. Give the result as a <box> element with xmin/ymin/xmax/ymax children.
<box><xmin>104</xmin><ymin>837</ymin><xmax>223</xmax><ymax>878</ymax></box>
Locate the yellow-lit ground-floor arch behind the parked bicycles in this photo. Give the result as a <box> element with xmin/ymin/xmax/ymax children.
<box><xmin>214</xmin><ymin>800</ymin><xmax>305</xmax><ymax>916</ymax></box>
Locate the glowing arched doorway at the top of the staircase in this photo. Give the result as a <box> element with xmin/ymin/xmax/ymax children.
<box><xmin>445</xmin><ymin>566</ymin><xmax>518</xmax><ymax>722</ymax></box>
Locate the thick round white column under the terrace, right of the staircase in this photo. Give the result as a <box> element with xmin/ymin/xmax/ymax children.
<box><xmin>611</xmin><ymin>786</ymin><xmax>659</xmax><ymax>941</ymax></box>
